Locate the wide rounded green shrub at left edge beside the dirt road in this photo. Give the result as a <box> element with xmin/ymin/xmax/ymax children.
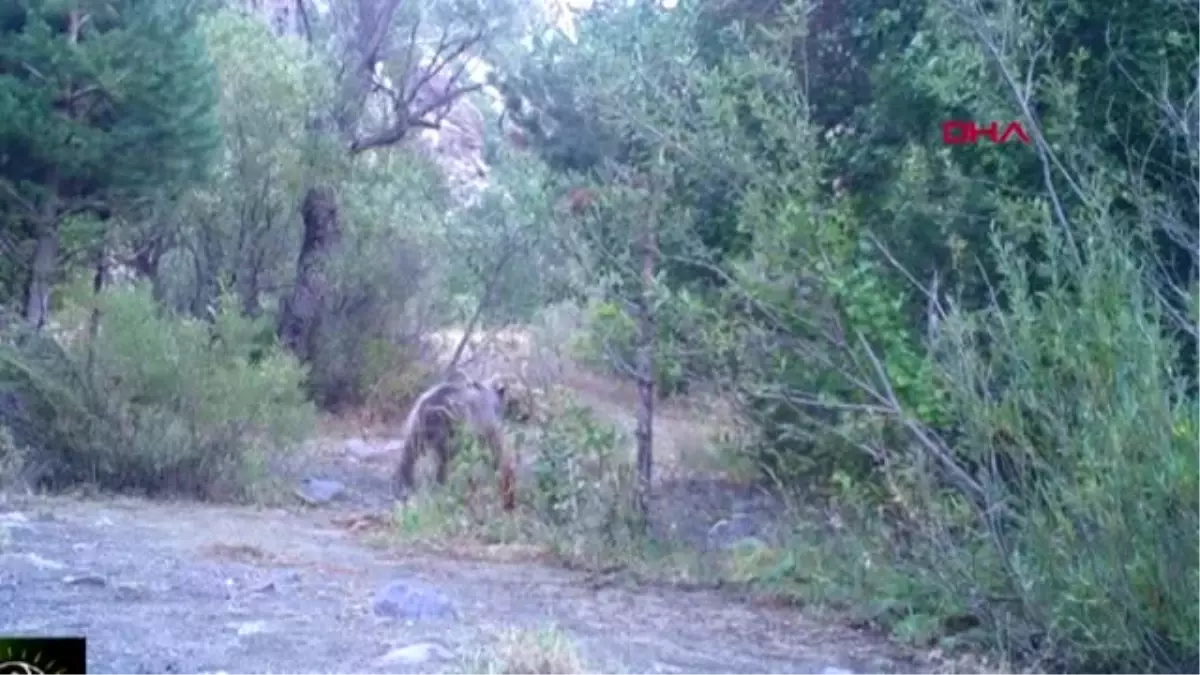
<box><xmin>0</xmin><ymin>281</ymin><xmax>313</xmax><ymax>497</ymax></box>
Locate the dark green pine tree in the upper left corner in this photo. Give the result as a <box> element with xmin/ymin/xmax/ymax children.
<box><xmin>0</xmin><ymin>0</ymin><xmax>220</xmax><ymax>325</ymax></box>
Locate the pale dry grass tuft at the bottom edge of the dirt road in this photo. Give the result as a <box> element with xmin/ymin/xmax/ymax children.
<box><xmin>456</xmin><ymin>628</ymin><xmax>594</xmax><ymax>675</ymax></box>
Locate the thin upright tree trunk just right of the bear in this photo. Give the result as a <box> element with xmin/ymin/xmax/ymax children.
<box><xmin>635</xmin><ymin>226</ymin><xmax>658</xmax><ymax>516</ymax></box>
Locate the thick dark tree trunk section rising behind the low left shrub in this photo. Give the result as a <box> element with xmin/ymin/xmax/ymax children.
<box><xmin>278</xmin><ymin>185</ymin><xmax>342</xmax><ymax>363</ymax></box>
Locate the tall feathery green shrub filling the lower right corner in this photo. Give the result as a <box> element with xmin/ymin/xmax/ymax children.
<box><xmin>849</xmin><ymin>205</ymin><xmax>1200</xmax><ymax>673</ymax></box>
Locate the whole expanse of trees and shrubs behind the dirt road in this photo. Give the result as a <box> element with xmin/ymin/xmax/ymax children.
<box><xmin>0</xmin><ymin>0</ymin><xmax>1200</xmax><ymax>673</ymax></box>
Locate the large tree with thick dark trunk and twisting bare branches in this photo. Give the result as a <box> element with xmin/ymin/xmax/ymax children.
<box><xmin>278</xmin><ymin>0</ymin><xmax>530</xmax><ymax>374</ymax></box>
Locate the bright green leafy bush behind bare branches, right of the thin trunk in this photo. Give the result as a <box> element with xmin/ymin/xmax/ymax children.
<box><xmin>716</xmin><ymin>193</ymin><xmax>946</xmax><ymax>494</ymax></box>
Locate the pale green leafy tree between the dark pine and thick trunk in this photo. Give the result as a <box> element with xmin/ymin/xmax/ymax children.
<box><xmin>140</xmin><ymin>10</ymin><xmax>331</xmax><ymax>316</ymax></box>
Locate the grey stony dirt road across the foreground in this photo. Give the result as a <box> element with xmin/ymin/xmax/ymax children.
<box><xmin>0</xmin><ymin>487</ymin><xmax>918</xmax><ymax>675</ymax></box>
